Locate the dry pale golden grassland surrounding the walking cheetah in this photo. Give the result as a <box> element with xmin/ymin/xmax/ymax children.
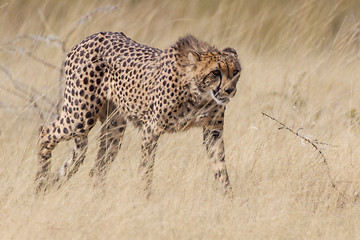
<box><xmin>0</xmin><ymin>0</ymin><xmax>360</xmax><ymax>239</ymax></box>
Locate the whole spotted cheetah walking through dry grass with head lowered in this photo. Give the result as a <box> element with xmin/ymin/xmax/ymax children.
<box><xmin>35</xmin><ymin>32</ymin><xmax>241</xmax><ymax>196</ymax></box>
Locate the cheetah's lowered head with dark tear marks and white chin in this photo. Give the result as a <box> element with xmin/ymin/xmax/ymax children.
<box><xmin>188</xmin><ymin>48</ymin><xmax>241</xmax><ymax>105</ymax></box>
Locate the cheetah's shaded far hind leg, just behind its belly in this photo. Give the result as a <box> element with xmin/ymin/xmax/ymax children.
<box><xmin>89</xmin><ymin>102</ymin><xmax>126</xmax><ymax>185</ymax></box>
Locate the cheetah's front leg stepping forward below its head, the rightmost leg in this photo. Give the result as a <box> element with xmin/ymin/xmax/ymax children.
<box><xmin>203</xmin><ymin>121</ymin><xmax>232</xmax><ymax>197</ymax></box>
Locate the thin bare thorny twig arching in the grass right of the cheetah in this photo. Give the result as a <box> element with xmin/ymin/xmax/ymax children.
<box><xmin>262</xmin><ymin>112</ymin><xmax>338</xmax><ymax>191</ymax></box>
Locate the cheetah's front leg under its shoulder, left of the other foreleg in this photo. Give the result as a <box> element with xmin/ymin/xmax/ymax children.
<box><xmin>139</xmin><ymin>127</ymin><xmax>160</xmax><ymax>198</ymax></box>
